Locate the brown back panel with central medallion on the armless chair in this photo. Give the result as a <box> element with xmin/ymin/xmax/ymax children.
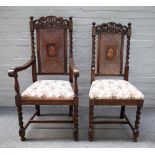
<box><xmin>96</xmin><ymin>32</ymin><xmax>124</xmax><ymax>75</ymax></box>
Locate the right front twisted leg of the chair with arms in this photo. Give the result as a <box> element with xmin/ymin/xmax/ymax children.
<box><xmin>73</xmin><ymin>103</ymin><xmax>79</xmax><ymax>141</ymax></box>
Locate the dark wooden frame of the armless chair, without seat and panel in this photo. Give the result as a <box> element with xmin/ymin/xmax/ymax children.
<box><xmin>88</xmin><ymin>22</ymin><xmax>144</xmax><ymax>142</ymax></box>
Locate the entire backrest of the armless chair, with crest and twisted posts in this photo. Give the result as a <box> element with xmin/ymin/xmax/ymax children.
<box><xmin>91</xmin><ymin>22</ymin><xmax>131</xmax><ymax>82</ymax></box>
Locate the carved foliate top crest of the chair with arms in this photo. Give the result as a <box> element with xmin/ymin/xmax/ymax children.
<box><xmin>33</xmin><ymin>16</ymin><xmax>69</xmax><ymax>29</ymax></box>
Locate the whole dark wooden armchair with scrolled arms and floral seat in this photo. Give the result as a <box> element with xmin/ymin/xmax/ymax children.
<box><xmin>8</xmin><ymin>16</ymin><xmax>79</xmax><ymax>141</ymax></box>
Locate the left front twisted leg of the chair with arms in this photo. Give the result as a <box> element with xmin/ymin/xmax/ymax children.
<box><xmin>17</xmin><ymin>105</ymin><xmax>25</xmax><ymax>141</ymax></box>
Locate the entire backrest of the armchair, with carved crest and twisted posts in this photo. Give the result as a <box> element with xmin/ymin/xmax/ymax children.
<box><xmin>30</xmin><ymin>16</ymin><xmax>73</xmax><ymax>77</ymax></box>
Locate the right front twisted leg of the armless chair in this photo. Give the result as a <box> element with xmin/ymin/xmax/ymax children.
<box><xmin>133</xmin><ymin>106</ymin><xmax>142</xmax><ymax>142</ymax></box>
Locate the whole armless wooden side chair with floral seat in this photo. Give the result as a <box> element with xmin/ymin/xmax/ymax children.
<box><xmin>88</xmin><ymin>22</ymin><xmax>144</xmax><ymax>142</ymax></box>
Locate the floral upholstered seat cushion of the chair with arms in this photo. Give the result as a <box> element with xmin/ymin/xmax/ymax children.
<box><xmin>21</xmin><ymin>80</ymin><xmax>74</xmax><ymax>99</ymax></box>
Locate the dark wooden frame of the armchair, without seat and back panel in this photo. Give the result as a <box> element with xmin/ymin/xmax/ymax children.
<box><xmin>8</xmin><ymin>16</ymin><xmax>79</xmax><ymax>141</ymax></box>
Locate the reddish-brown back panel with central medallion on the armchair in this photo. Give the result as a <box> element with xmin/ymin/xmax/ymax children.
<box><xmin>36</xmin><ymin>28</ymin><xmax>67</xmax><ymax>74</ymax></box>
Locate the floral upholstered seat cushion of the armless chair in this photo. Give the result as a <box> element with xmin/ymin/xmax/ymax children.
<box><xmin>89</xmin><ymin>80</ymin><xmax>144</xmax><ymax>99</ymax></box>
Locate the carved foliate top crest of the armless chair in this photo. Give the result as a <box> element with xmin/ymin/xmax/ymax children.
<box><xmin>96</xmin><ymin>22</ymin><xmax>128</xmax><ymax>34</ymax></box>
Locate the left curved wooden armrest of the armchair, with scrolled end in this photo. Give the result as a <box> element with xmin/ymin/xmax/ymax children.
<box><xmin>8</xmin><ymin>58</ymin><xmax>35</xmax><ymax>77</ymax></box>
